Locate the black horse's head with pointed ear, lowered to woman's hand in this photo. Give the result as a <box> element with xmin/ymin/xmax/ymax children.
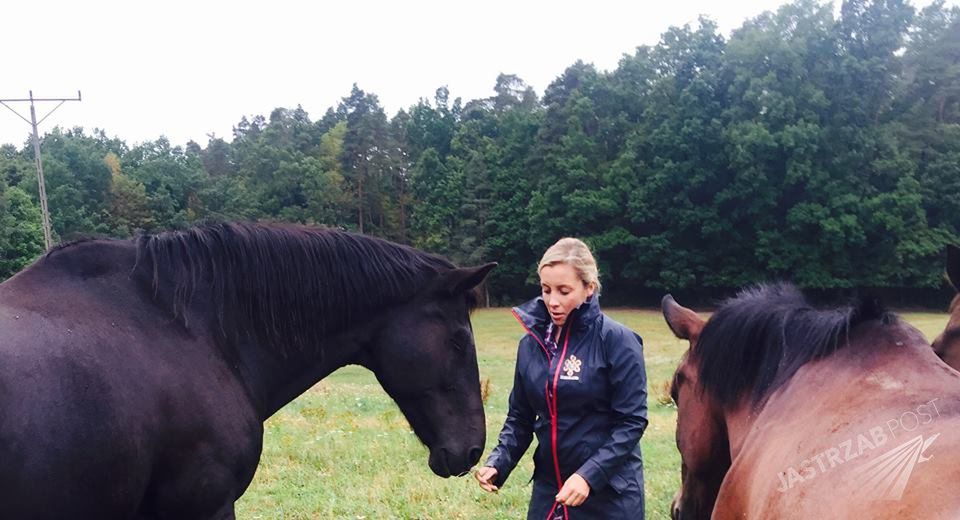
<box><xmin>364</xmin><ymin>264</ymin><xmax>496</xmax><ymax>477</ymax></box>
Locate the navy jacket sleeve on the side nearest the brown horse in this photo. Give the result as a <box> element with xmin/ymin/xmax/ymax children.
<box><xmin>577</xmin><ymin>326</ymin><xmax>647</xmax><ymax>491</ymax></box>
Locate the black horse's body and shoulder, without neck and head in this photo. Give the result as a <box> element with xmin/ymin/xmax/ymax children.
<box><xmin>0</xmin><ymin>240</ymin><xmax>262</xmax><ymax>518</ymax></box>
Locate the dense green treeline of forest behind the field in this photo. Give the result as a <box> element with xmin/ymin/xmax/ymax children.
<box><xmin>0</xmin><ymin>0</ymin><xmax>960</xmax><ymax>303</ymax></box>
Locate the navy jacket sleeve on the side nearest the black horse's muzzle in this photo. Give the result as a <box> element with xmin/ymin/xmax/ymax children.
<box><xmin>486</xmin><ymin>340</ymin><xmax>536</xmax><ymax>487</ymax></box>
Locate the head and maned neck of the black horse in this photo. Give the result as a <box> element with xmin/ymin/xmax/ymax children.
<box><xmin>137</xmin><ymin>223</ymin><xmax>496</xmax><ymax>477</ymax></box>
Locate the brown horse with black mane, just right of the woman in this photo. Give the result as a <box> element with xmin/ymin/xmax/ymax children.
<box><xmin>662</xmin><ymin>284</ymin><xmax>960</xmax><ymax>519</ymax></box>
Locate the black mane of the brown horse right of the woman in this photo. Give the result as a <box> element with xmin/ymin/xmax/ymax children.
<box><xmin>696</xmin><ymin>283</ymin><xmax>894</xmax><ymax>406</ymax></box>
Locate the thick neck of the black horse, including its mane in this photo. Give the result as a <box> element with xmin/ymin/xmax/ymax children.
<box><xmin>130</xmin><ymin>224</ymin><xmax>453</xmax><ymax>416</ymax></box>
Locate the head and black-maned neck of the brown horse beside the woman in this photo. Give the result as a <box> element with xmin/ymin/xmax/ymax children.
<box><xmin>662</xmin><ymin>283</ymin><xmax>880</xmax><ymax>518</ymax></box>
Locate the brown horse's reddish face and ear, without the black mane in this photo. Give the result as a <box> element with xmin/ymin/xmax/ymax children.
<box><xmin>661</xmin><ymin>295</ymin><xmax>730</xmax><ymax>520</ymax></box>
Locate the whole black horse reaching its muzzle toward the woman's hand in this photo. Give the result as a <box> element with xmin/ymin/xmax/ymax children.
<box><xmin>0</xmin><ymin>224</ymin><xmax>495</xmax><ymax>519</ymax></box>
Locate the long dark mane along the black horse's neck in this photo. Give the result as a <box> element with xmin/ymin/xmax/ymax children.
<box><xmin>137</xmin><ymin>223</ymin><xmax>464</xmax><ymax>352</ymax></box>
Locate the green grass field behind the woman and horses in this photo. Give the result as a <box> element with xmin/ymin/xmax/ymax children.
<box><xmin>237</xmin><ymin>309</ymin><xmax>947</xmax><ymax>520</ymax></box>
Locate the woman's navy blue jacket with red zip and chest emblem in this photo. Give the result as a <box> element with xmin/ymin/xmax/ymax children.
<box><xmin>486</xmin><ymin>296</ymin><xmax>647</xmax><ymax>498</ymax></box>
